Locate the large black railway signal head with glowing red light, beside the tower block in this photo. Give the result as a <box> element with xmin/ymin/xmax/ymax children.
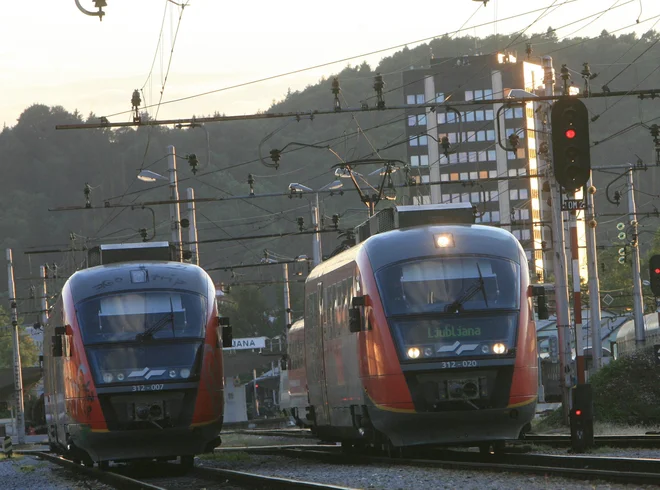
<box><xmin>550</xmin><ymin>97</ymin><xmax>591</xmax><ymax>191</ymax></box>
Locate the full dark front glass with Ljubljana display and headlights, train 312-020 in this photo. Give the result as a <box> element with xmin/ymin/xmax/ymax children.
<box><xmin>376</xmin><ymin>256</ymin><xmax>520</xmax><ymax>360</ymax></box>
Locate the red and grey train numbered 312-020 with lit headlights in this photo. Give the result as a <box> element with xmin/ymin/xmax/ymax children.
<box><xmin>298</xmin><ymin>205</ymin><xmax>537</xmax><ymax>447</ymax></box>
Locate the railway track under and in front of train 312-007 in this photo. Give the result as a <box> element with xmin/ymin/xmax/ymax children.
<box><xmin>17</xmin><ymin>451</ymin><xmax>356</xmax><ymax>490</ymax></box>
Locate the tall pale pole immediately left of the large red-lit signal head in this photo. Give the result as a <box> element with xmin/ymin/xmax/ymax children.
<box><xmin>543</xmin><ymin>56</ymin><xmax>571</xmax><ymax>422</ymax></box>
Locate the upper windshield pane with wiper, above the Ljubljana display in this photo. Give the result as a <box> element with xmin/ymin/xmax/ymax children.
<box><xmin>376</xmin><ymin>256</ymin><xmax>520</xmax><ymax>316</ymax></box>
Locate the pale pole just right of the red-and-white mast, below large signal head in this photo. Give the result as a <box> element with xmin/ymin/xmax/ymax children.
<box><xmin>584</xmin><ymin>179</ymin><xmax>603</xmax><ymax>373</ymax></box>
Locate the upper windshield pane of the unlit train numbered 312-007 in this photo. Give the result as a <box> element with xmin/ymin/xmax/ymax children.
<box><xmin>77</xmin><ymin>291</ymin><xmax>206</xmax><ymax>344</ymax></box>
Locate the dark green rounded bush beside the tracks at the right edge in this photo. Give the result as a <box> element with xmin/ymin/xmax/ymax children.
<box><xmin>590</xmin><ymin>346</ymin><xmax>660</xmax><ymax>425</ymax></box>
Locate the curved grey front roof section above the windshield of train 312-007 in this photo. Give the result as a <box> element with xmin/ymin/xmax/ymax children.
<box><xmin>67</xmin><ymin>261</ymin><xmax>213</xmax><ymax>303</ymax></box>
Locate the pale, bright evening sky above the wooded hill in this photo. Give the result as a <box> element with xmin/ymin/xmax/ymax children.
<box><xmin>0</xmin><ymin>0</ymin><xmax>660</xmax><ymax>126</ymax></box>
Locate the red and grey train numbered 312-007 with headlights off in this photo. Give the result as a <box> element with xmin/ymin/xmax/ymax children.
<box><xmin>44</xmin><ymin>251</ymin><xmax>231</xmax><ymax>465</ymax></box>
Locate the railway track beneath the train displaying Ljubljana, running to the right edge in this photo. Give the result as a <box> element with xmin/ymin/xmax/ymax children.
<box><xmin>216</xmin><ymin>446</ymin><xmax>660</xmax><ymax>485</ymax></box>
